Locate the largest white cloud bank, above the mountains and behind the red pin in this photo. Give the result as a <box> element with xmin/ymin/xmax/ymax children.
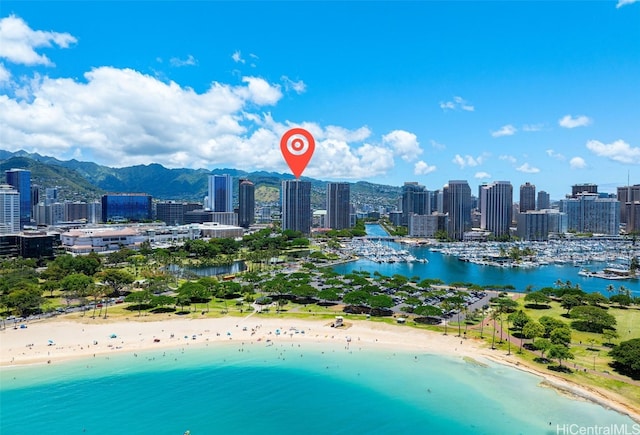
<box><xmin>0</xmin><ymin>62</ymin><xmax>416</xmax><ymax>179</ymax></box>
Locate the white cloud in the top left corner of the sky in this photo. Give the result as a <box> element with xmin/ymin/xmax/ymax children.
<box><xmin>0</xmin><ymin>15</ymin><xmax>77</xmax><ymax>66</ymax></box>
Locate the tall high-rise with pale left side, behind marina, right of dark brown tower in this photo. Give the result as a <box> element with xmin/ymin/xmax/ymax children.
<box><xmin>480</xmin><ymin>181</ymin><xmax>522</xmax><ymax>237</ymax></box>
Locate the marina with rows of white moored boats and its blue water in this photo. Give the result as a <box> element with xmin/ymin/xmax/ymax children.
<box><xmin>333</xmin><ymin>225</ymin><xmax>640</xmax><ymax>296</ymax></box>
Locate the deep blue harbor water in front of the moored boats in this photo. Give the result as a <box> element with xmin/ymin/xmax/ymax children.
<box><xmin>334</xmin><ymin>225</ymin><xmax>640</xmax><ymax>296</ymax></box>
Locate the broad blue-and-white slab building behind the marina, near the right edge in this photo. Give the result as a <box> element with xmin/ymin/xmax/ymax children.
<box><xmin>560</xmin><ymin>193</ymin><xmax>620</xmax><ymax>235</ymax></box>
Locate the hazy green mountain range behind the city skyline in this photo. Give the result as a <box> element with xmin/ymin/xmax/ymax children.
<box><xmin>0</xmin><ymin>150</ymin><xmax>400</xmax><ymax>209</ymax></box>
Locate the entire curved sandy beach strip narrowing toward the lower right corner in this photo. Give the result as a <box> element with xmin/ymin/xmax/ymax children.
<box><xmin>0</xmin><ymin>315</ymin><xmax>640</xmax><ymax>423</ymax></box>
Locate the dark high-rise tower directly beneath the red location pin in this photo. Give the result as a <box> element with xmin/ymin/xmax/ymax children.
<box><xmin>280</xmin><ymin>180</ymin><xmax>312</xmax><ymax>234</ymax></box>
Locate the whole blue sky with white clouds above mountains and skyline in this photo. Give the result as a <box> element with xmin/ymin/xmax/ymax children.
<box><xmin>0</xmin><ymin>0</ymin><xmax>640</xmax><ymax>200</ymax></box>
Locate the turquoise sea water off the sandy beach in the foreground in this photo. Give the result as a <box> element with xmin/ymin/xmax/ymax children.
<box><xmin>0</xmin><ymin>343</ymin><xmax>633</xmax><ymax>435</ymax></box>
